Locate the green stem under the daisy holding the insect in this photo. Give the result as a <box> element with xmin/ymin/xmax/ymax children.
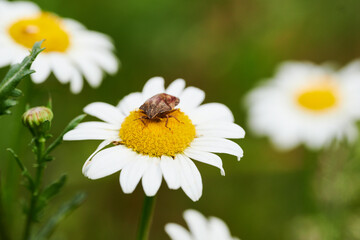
<box><xmin>136</xmin><ymin>196</ymin><xmax>155</xmax><ymax>240</ymax></box>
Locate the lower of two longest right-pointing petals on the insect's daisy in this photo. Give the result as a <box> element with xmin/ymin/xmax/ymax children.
<box><xmin>191</xmin><ymin>137</ymin><xmax>244</xmax><ymax>160</ymax></box>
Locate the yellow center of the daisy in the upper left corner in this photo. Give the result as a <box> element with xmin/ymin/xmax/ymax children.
<box><xmin>8</xmin><ymin>13</ymin><xmax>70</xmax><ymax>52</ymax></box>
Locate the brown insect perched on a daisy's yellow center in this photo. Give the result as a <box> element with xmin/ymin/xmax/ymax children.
<box><xmin>136</xmin><ymin>93</ymin><xmax>180</xmax><ymax>129</ymax></box>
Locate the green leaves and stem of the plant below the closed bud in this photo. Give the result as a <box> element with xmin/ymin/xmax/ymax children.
<box><xmin>4</xmin><ymin>111</ymin><xmax>86</xmax><ymax>239</ymax></box>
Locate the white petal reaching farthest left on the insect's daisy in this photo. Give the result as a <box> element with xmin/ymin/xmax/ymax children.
<box><xmin>63</xmin><ymin>128</ymin><xmax>119</xmax><ymax>141</ymax></box>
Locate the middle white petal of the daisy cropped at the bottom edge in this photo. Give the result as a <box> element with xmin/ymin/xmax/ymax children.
<box><xmin>184</xmin><ymin>210</ymin><xmax>210</xmax><ymax>240</ymax></box>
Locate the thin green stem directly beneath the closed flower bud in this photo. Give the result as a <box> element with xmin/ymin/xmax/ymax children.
<box><xmin>23</xmin><ymin>137</ymin><xmax>46</xmax><ymax>240</ymax></box>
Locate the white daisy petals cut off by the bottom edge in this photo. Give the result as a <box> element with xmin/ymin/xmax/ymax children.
<box><xmin>165</xmin><ymin>209</ymin><xmax>239</xmax><ymax>240</ymax></box>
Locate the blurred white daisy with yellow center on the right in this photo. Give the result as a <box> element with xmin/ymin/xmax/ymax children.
<box><xmin>247</xmin><ymin>62</ymin><xmax>360</xmax><ymax>150</ymax></box>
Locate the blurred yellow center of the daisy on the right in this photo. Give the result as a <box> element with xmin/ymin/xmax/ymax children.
<box><xmin>297</xmin><ymin>77</ymin><xmax>339</xmax><ymax>112</ymax></box>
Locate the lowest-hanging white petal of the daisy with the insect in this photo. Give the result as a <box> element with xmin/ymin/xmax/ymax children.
<box><xmin>175</xmin><ymin>154</ymin><xmax>202</xmax><ymax>202</ymax></box>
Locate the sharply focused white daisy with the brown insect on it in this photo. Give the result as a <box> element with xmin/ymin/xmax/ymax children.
<box><xmin>64</xmin><ymin>77</ymin><xmax>245</xmax><ymax>201</ymax></box>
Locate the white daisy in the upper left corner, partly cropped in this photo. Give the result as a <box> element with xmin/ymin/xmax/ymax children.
<box><xmin>0</xmin><ymin>1</ymin><xmax>118</xmax><ymax>93</ymax></box>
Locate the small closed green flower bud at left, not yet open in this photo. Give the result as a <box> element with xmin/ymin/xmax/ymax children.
<box><xmin>22</xmin><ymin>107</ymin><xmax>53</xmax><ymax>135</ymax></box>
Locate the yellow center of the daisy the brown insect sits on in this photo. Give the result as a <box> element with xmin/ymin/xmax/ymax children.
<box><xmin>119</xmin><ymin>110</ymin><xmax>195</xmax><ymax>157</ymax></box>
